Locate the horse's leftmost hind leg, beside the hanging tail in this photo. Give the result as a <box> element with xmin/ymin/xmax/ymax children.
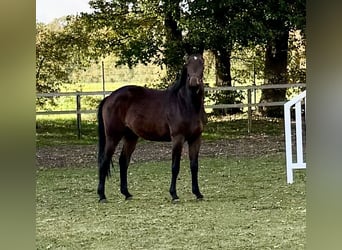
<box><xmin>97</xmin><ymin>138</ymin><xmax>121</xmax><ymax>202</ymax></box>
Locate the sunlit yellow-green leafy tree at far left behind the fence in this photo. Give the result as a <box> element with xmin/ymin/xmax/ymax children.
<box><xmin>36</xmin><ymin>17</ymin><xmax>96</xmax><ymax>106</ymax></box>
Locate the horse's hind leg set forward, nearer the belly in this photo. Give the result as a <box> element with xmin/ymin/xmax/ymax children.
<box><xmin>119</xmin><ymin>132</ymin><xmax>138</xmax><ymax>200</ymax></box>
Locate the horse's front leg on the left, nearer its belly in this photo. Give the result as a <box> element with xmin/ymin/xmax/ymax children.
<box><xmin>170</xmin><ymin>137</ymin><xmax>184</xmax><ymax>201</ymax></box>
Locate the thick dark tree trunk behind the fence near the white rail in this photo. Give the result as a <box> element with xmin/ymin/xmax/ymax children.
<box><xmin>260</xmin><ymin>29</ymin><xmax>289</xmax><ymax>117</ymax></box>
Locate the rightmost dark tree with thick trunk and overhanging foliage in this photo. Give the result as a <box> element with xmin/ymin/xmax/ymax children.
<box><xmin>259</xmin><ymin>0</ymin><xmax>305</xmax><ymax>117</ymax></box>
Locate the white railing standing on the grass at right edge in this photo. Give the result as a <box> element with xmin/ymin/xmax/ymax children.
<box><xmin>284</xmin><ymin>91</ymin><xmax>306</xmax><ymax>183</ymax></box>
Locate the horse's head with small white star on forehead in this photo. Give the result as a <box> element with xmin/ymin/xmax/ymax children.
<box><xmin>185</xmin><ymin>54</ymin><xmax>204</xmax><ymax>89</ymax></box>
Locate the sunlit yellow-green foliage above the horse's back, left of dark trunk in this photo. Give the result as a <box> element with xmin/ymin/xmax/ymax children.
<box><xmin>84</xmin><ymin>0</ymin><xmax>164</xmax><ymax>67</ymax></box>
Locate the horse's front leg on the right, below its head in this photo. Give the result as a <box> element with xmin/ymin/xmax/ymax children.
<box><xmin>189</xmin><ymin>137</ymin><xmax>203</xmax><ymax>199</ymax></box>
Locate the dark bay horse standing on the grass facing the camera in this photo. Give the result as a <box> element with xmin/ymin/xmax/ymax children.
<box><xmin>97</xmin><ymin>54</ymin><xmax>206</xmax><ymax>202</ymax></box>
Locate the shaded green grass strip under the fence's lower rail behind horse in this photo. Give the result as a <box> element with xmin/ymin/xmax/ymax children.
<box><xmin>36</xmin><ymin>115</ymin><xmax>284</xmax><ymax>147</ymax></box>
